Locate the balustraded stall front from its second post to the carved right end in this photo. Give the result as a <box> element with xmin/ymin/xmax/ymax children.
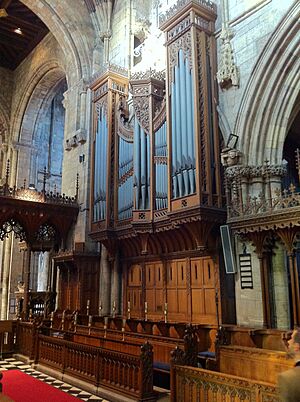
<box><xmin>36</xmin><ymin>335</ymin><xmax>153</xmax><ymax>401</ymax></box>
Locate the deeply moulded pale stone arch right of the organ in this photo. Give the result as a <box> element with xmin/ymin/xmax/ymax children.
<box><xmin>234</xmin><ymin>2</ymin><xmax>300</xmax><ymax>165</ymax></box>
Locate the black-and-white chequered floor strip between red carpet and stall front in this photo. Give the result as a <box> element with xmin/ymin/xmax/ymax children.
<box><xmin>0</xmin><ymin>358</ymin><xmax>109</xmax><ymax>402</ymax></box>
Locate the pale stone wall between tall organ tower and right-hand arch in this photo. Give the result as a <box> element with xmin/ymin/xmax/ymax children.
<box><xmin>218</xmin><ymin>0</ymin><xmax>294</xmax><ymax>141</ymax></box>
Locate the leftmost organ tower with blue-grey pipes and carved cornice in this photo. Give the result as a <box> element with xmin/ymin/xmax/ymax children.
<box><xmin>91</xmin><ymin>65</ymin><xmax>129</xmax><ymax>228</ymax></box>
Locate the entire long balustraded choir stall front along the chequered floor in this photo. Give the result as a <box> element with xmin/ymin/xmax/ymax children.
<box><xmin>17</xmin><ymin>322</ymin><xmax>155</xmax><ymax>401</ymax></box>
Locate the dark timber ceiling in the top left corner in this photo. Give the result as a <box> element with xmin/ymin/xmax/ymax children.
<box><xmin>0</xmin><ymin>0</ymin><xmax>48</xmax><ymax>70</ymax></box>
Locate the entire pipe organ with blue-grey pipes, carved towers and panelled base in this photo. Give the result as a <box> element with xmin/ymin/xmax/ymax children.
<box><xmin>90</xmin><ymin>1</ymin><xmax>233</xmax><ymax>324</ymax></box>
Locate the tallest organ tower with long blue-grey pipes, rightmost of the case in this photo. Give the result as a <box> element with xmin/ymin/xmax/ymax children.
<box><xmin>160</xmin><ymin>0</ymin><xmax>222</xmax><ymax>210</ymax></box>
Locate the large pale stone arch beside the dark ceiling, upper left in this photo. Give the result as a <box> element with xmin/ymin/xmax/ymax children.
<box><xmin>21</xmin><ymin>0</ymin><xmax>94</xmax><ymax>86</ymax></box>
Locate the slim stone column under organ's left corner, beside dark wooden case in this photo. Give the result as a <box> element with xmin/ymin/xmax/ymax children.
<box><xmin>100</xmin><ymin>245</ymin><xmax>111</xmax><ymax>315</ymax></box>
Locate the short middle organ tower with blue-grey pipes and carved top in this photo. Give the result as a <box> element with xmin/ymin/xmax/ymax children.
<box><xmin>130</xmin><ymin>69</ymin><xmax>168</xmax><ymax>214</ymax></box>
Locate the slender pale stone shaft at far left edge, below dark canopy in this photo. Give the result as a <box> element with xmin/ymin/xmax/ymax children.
<box><xmin>1</xmin><ymin>234</ymin><xmax>13</xmax><ymax>320</ymax></box>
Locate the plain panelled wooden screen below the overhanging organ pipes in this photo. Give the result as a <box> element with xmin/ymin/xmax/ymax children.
<box><xmin>126</xmin><ymin>257</ymin><xmax>219</xmax><ymax>324</ymax></box>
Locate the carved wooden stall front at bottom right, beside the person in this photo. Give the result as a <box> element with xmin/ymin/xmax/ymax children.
<box><xmin>171</xmin><ymin>365</ymin><xmax>280</xmax><ymax>402</ymax></box>
